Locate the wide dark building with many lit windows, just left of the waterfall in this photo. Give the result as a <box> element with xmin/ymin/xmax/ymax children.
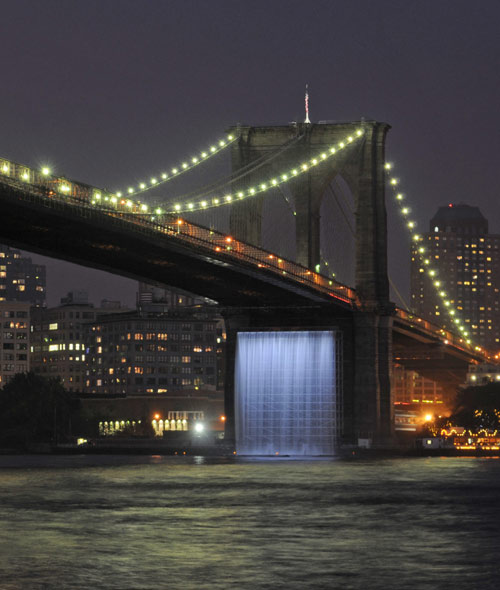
<box><xmin>85</xmin><ymin>303</ymin><xmax>220</xmax><ymax>396</ymax></box>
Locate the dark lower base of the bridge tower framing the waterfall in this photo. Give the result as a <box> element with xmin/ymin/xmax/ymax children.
<box><xmin>223</xmin><ymin>305</ymin><xmax>393</xmax><ymax>454</ymax></box>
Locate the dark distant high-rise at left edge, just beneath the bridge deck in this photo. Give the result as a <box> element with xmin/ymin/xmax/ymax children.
<box><xmin>0</xmin><ymin>245</ymin><xmax>45</xmax><ymax>307</ymax></box>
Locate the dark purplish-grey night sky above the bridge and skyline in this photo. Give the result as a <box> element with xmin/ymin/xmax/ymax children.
<box><xmin>0</xmin><ymin>0</ymin><xmax>500</xmax><ymax>305</ymax></box>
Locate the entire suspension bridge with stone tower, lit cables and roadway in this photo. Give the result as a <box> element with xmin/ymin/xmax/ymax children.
<box><xmin>0</xmin><ymin>121</ymin><xmax>488</xmax><ymax>454</ymax></box>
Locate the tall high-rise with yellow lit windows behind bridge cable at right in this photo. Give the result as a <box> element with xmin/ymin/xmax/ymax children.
<box><xmin>411</xmin><ymin>204</ymin><xmax>500</xmax><ymax>351</ymax></box>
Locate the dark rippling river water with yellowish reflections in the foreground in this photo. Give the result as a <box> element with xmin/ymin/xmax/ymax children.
<box><xmin>0</xmin><ymin>456</ymin><xmax>500</xmax><ymax>590</ymax></box>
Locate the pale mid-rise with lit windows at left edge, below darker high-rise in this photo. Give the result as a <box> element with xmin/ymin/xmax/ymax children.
<box><xmin>0</xmin><ymin>301</ymin><xmax>31</xmax><ymax>387</ymax></box>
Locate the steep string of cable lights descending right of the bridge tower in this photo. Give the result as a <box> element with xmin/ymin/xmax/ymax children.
<box><xmin>384</xmin><ymin>162</ymin><xmax>484</xmax><ymax>353</ymax></box>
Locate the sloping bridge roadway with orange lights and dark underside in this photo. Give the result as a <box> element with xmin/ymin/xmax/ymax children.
<box><xmin>0</xmin><ymin>169</ymin><xmax>486</xmax><ymax>442</ymax></box>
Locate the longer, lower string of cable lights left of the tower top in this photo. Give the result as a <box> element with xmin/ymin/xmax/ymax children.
<box><xmin>164</xmin><ymin>128</ymin><xmax>363</xmax><ymax>215</ymax></box>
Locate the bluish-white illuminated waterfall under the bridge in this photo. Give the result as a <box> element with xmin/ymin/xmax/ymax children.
<box><xmin>235</xmin><ymin>331</ymin><xmax>337</xmax><ymax>455</ymax></box>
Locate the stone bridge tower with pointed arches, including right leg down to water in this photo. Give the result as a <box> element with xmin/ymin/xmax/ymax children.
<box><xmin>230</xmin><ymin>121</ymin><xmax>394</xmax><ymax>442</ymax></box>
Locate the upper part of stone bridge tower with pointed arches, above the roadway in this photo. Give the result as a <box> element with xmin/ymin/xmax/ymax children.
<box><xmin>230</xmin><ymin>121</ymin><xmax>390</xmax><ymax>308</ymax></box>
